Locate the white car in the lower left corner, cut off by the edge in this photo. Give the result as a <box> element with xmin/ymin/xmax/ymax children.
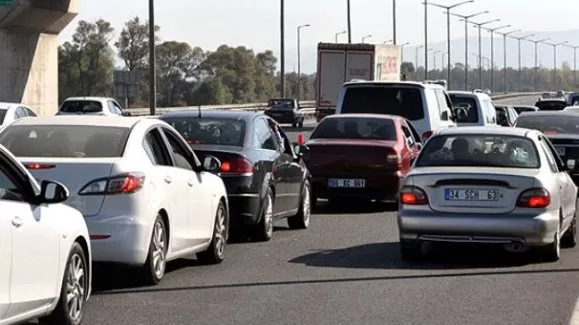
<box><xmin>0</xmin><ymin>146</ymin><xmax>92</xmax><ymax>325</ymax></box>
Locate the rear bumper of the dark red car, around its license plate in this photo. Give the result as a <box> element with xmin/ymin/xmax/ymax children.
<box><xmin>312</xmin><ymin>174</ymin><xmax>401</xmax><ymax>200</ymax></box>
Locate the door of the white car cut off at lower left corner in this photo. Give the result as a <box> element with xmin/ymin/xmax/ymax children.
<box><xmin>0</xmin><ymin>154</ymin><xmax>61</xmax><ymax>318</ymax></box>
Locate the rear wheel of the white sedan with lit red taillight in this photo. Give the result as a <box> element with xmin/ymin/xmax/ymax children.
<box><xmin>142</xmin><ymin>215</ymin><xmax>169</xmax><ymax>285</ymax></box>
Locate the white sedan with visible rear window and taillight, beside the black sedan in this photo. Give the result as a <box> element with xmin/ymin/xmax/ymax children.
<box><xmin>0</xmin><ymin>115</ymin><xmax>229</xmax><ymax>284</ymax></box>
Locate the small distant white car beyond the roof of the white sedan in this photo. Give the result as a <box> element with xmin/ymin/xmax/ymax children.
<box><xmin>56</xmin><ymin>97</ymin><xmax>131</xmax><ymax>116</ymax></box>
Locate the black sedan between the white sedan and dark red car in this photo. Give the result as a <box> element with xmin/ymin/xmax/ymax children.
<box><xmin>160</xmin><ymin>111</ymin><xmax>311</xmax><ymax>241</ymax></box>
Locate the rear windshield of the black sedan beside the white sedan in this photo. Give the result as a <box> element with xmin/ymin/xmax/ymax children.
<box><xmin>162</xmin><ymin>117</ymin><xmax>246</xmax><ymax>147</ymax></box>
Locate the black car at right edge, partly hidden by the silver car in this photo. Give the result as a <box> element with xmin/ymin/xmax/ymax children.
<box><xmin>515</xmin><ymin>111</ymin><xmax>579</xmax><ymax>185</ymax></box>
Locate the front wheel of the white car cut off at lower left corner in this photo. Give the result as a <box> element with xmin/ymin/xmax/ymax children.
<box><xmin>41</xmin><ymin>242</ymin><xmax>89</xmax><ymax>325</ymax></box>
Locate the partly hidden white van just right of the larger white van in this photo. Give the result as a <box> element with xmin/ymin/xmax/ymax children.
<box><xmin>448</xmin><ymin>91</ymin><xmax>497</xmax><ymax>126</ymax></box>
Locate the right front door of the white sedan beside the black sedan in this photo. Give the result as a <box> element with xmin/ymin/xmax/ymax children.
<box><xmin>161</xmin><ymin>127</ymin><xmax>214</xmax><ymax>248</ymax></box>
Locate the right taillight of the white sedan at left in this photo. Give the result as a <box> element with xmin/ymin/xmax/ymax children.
<box><xmin>78</xmin><ymin>173</ymin><xmax>145</xmax><ymax>195</ymax></box>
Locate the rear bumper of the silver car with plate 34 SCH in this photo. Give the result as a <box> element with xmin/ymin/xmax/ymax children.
<box><xmin>398</xmin><ymin>210</ymin><xmax>559</xmax><ymax>246</ymax></box>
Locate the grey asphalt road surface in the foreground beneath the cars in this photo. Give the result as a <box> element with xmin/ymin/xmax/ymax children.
<box><xmin>80</xmin><ymin>93</ymin><xmax>579</xmax><ymax>325</ymax></box>
